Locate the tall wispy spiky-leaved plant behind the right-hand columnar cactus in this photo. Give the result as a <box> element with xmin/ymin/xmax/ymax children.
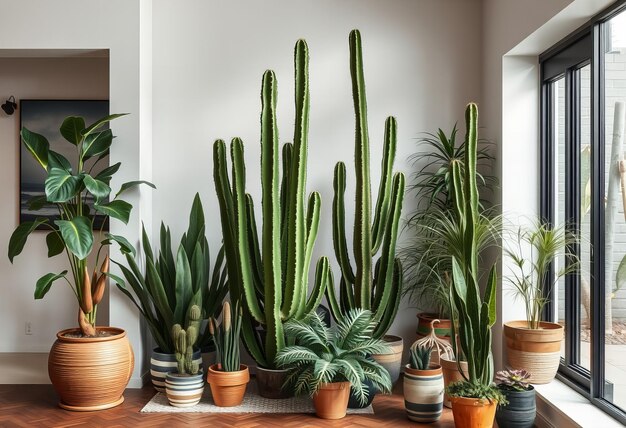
<box><xmin>400</xmin><ymin>125</ymin><xmax>496</xmax><ymax>341</ymax></box>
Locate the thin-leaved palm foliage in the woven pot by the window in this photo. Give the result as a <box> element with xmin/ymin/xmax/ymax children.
<box><xmin>504</xmin><ymin>220</ymin><xmax>579</xmax><ymax>329</ymax></box>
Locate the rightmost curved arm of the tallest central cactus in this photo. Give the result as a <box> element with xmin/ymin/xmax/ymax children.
<box><xmin>372</xmin><ymin>173</ymin><xmax>404</xmax><ymax>322</ymax></box>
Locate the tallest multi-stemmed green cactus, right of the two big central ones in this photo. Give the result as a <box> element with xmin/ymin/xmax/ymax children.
<box><xmin>326</xmin><ymin>30</ymin><xmax>405</xmax><ymax>337</ymax></box>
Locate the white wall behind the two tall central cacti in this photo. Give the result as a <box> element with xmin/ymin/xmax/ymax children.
<box><xmin>153</xmin><ymin>0</ymin><xmax>481</xmax><ymax>362</ymax></box>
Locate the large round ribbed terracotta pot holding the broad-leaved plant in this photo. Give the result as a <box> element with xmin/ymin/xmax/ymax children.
<box><xmin>48</xmin><ymin>327</ymin><xmax>135</xmax><ymax>411</ymax></box>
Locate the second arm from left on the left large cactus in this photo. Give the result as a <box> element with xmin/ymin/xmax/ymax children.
<box><xmin>230</xmin><ymin>138</ymin><xmax>265</xmax><ymax>323</ymax></box>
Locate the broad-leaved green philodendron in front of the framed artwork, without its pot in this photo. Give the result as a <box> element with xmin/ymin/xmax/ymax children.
<box><xmin>9</xmin><ymin>114</ymin><xmax>154</xmax><ymax>336</ymax></box>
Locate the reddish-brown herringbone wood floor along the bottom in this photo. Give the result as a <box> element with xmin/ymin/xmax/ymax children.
<box><xmin>0</xmin><ymin>385</ymin><xmax>454</xmax><ymax>428</ymax></box>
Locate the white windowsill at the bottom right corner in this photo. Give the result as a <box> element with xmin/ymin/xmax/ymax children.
<box><xmin>534</xmin><ymin>379</ymin><xmax>623</xmax><ymax>428</ymax></box>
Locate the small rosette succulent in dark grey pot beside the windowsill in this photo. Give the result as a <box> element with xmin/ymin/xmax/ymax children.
<box><xmin>496</xmin><ymin>370</ymin><xmax>537</xmax><ymax>428</ymax></box>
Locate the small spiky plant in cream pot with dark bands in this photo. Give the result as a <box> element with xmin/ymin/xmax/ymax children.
<box><xmin>404</xmin><ymin>344</ymin><xmax>444</xmax><ymax>423</ymax></box>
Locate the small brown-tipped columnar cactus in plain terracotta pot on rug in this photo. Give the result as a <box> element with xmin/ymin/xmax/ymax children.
<box><xmin>207</xmin><ymin>302</ymin><xmax>250</xmax><ymax>407</ymax></box>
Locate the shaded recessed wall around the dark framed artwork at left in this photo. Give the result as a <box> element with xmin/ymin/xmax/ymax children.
<box><xmin>0</xmin><ymin>58</ymin><xmax>109</xmax><ymax>352</ymax></box>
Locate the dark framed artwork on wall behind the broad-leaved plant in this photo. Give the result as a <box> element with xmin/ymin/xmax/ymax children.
<box><xmin>19</xmin><ymin>100</ymin><xmax>109</xmax><ymax>230</ymax></box>
